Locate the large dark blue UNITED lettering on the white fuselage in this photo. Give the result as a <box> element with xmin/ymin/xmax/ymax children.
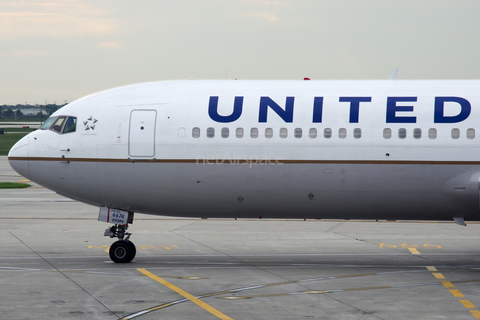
<box><xmin>208</xmin><ymin>96</ymin><xmax>472</xmax><ymax>123</ymax></box>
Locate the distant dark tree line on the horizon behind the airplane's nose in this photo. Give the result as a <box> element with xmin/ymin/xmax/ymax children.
<box><xmin>0</xmin><ymin>104</ymin><xmax>65</xmax><ymax>121</ymax></box>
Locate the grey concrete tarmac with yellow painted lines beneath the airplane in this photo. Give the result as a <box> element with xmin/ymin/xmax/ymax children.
<box><xmin>0</xmin><ymin>157</ymin><xmax>480</xmax><ymax>320</ymax></box>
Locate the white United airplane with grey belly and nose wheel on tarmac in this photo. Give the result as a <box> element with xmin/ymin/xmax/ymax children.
<box><xmin>8</xmin><ymin>79</ymin><xmax>480</xmax><ymax>263</ymax></box>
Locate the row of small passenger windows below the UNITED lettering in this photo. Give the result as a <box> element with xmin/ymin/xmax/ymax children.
<box><xmin>192</xmin><ymin>127</ymin><xmax>475</xmax><ymax>139</ymax></box>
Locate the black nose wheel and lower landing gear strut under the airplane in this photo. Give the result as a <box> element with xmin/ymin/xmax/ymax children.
<box><xmin>104</xmin><ymin>224</ymin><xmax>137</xmax><ymax>263</ymax></box>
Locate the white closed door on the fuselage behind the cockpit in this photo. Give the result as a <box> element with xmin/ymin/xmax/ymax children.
<box><xmin>128</xmin><ymin>110</ymin><xmax>157</xmax><ymax>157</ymax></box>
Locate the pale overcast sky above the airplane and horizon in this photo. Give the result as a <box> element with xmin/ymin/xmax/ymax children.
<box><xmin>0</xmin><ymin>0</ymin><xmax>480</xmax><ymax>105</ymax></box>
